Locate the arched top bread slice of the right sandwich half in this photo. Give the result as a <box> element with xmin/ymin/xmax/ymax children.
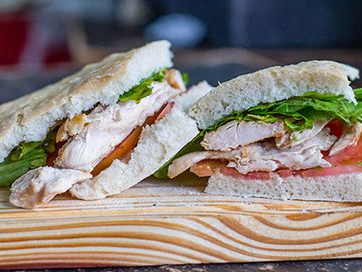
<box><xmin>189</xmin><ymin>60</ymin><xmax>359</xmax><ymax>129</ymax></box>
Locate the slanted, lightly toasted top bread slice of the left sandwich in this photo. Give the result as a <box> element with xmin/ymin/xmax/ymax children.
<box><xmin>0</xmin><ymin>41</ymin><xmax>172</xmax><ymax>162</ymax></box>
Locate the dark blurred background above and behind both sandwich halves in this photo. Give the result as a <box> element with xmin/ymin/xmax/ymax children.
<box><xmin>0</xmin><ymin>0</ymin><xmax>362</xmax><ymax>103</ymax></box>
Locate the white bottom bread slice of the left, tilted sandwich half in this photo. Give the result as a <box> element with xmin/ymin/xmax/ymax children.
<box><xmin>70</xmin><ymin>107</ymin><xmax>199</xmax><ymax>200</ymax></box>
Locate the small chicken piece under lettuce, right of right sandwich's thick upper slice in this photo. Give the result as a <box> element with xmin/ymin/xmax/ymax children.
<box><xmin>275</xmin><ymin>120</ymin><xmax>330</xmax><ymax>149</ymax></box>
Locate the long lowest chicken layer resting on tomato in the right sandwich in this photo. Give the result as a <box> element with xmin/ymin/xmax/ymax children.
<box><xmin>168</xmin><ymin>128</ymin><xmax>336</xmax><ymax>178</ymax></box>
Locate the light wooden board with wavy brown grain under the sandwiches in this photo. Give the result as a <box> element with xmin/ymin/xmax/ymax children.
<box><xmin>0</xmin><ymin>174</ymin><xmax>362</xmax><ymax>269</ymax></box>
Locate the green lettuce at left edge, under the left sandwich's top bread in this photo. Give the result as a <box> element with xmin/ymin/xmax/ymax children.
<box><xmin>0</xmin><ymin>132</ymin><xmax>55</xmax><ymax>187</ymax></box>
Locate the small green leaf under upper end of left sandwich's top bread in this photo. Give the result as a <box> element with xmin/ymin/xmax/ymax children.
<box><xmin>118</xmin><ymin>69</ymin><xmax>166</xmax><ymax>104</ymax></box>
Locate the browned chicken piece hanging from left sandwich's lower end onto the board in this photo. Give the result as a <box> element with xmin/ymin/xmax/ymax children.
<box><xmin>9</xmin><ymin>167</ymin><xmax>92</xmax><ymax>209</ymax></box>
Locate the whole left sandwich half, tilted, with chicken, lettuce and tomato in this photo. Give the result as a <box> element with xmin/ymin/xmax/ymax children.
<box><xmin>0</xmin><ymin>41</ymin><xmax>210</xmax><ymax>208</ymax></box>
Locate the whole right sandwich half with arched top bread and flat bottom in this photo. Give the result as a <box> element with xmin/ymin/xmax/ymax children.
<box><xmin>155</xmin><ymin>61</ymin><xmax>362</xmax><ymax>202</ymax></box>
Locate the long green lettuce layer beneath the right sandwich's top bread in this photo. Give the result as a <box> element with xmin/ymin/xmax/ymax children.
<box><xmin>154</xmin><ymin>88</ymin><xmax>362</xmax><ymax>179</ymax></box>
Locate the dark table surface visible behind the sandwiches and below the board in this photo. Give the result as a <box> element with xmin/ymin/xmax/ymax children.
<box><xmin>0</xmin><ymin>49</ymin><xmax>362</xmax><ymax>272</ymax></box>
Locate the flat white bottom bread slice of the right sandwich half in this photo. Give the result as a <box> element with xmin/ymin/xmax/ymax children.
<box><xmin>205</xmin><ymin>173</ymin><xmax>362</xmax><ymax>202</ymax></box>
